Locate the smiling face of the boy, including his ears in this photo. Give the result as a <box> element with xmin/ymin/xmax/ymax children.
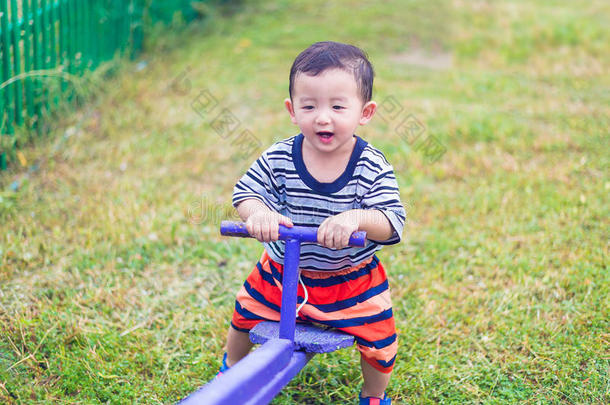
<box><xmin>284</xmin><ymin>69</ymin><xmax>377</xmax><ymax>157</ymax></box>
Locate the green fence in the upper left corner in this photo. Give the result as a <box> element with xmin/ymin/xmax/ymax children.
<box><xmin>0</xmin><ymin>0</ymin><xmax>195</xmax><ymax>170</ymax></box>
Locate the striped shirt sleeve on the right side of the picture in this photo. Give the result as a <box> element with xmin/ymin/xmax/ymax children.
<box><xmin>362</xmin><ymin>165</ymin><xmax>406</xmax><ymax>245</ymax></box>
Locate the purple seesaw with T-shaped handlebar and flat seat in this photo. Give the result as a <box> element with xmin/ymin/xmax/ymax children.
<box><xmin>180</xmin><ymin>221</ymin><xmax>366</xmax><ymax>405</ymax></box>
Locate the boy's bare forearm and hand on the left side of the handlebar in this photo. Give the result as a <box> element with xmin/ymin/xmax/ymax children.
<box><xmin>237</xmin><ymin>198</ymin><xmax>290</xmax><ymax>242</ymax></box>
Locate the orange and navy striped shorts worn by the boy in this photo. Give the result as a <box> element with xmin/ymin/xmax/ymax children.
<box><xmin>231</xmin><ymin>251</ymin><xmax>398</xmax><ymax>373</ymax></box>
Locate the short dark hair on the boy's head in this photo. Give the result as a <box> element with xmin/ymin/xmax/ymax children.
<box><xmin>288</xmin><ymin>41</ymin><xmax>375</xmax><ymax>103</ymax></box>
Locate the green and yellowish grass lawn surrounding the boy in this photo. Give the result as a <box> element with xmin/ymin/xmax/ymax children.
<box><xmin>0</xmin><ymin>0</ymin><xmax>610</xmax><ymax>404</ymax></box>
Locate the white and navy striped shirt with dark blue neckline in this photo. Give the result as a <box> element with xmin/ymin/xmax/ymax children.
<box><xmin>233</xmin><ymin>134</ymin><xmax>406</xmax><ymax>271</ymax></box>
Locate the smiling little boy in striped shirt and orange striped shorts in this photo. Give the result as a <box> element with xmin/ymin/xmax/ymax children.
<box><xmin>220</xmin><ymin>42</ymin><xmax>405</xmax><ymax>404</ymax></box>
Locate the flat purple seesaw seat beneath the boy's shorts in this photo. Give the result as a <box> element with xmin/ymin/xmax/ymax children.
<box><xmin>250</xmin><ymin>322</ymin><xmax>354</xmax><ymax>353</ymax></box>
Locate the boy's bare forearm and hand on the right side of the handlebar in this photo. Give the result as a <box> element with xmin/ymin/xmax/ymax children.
<box><xmin>318</xmin><ymin>209</ymin><xmax>394</xmax><ymax>249</ymax></box>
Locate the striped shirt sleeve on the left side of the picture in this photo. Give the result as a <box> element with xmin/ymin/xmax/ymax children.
<box><xmin>232</xmin><ymin>152</ymin><xmax>280</xmax><ymax>211</ymax></box>
